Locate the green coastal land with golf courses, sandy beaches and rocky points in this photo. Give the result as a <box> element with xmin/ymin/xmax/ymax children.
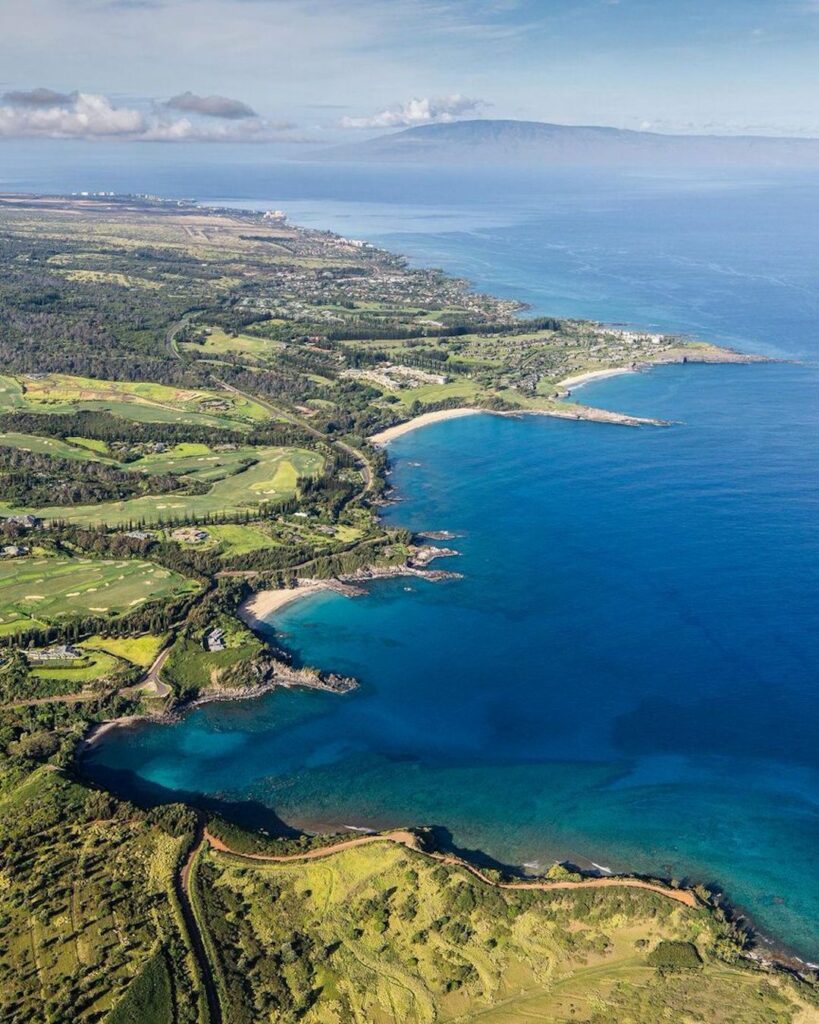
<box><xmin>0</xmin><ymin>195</ymin><xmax>819</xmax><ymax>1024</ymax></box>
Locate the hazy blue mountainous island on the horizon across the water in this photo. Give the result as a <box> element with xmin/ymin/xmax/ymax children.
<box><xmin>321</xmin><ymin>119</ymin><xmax>819</xmax><ymax>170</ymax></box>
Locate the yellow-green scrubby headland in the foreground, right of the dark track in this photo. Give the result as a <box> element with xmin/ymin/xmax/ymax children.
<box><xmin>199</xmin><ymin>844</ymin><xmax>817</xmax><ymax>1024</ymax></box>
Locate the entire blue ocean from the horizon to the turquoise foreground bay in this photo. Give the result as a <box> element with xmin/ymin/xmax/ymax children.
<box><xmin>11</xmin><ymin>146</ymin><xmax>819</xmax><ymax>959</ymax></box>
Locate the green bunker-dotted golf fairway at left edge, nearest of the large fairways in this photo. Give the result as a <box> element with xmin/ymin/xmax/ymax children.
<box><xmin>0</xmin><ymin>557</ymin><xmax>199</xmax><ymax>635</ymax></box>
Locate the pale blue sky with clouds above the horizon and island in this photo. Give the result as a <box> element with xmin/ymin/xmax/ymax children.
<box><xmin>0</xmin><ymin>0</ymin><xmax>819</xmax><ymax>143</ymax></box>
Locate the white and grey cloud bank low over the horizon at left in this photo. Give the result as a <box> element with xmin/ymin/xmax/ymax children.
<box><xmin>0</xmin><ymin>87</ymin><xmax>293</xmax><ymax>142</ymax></box>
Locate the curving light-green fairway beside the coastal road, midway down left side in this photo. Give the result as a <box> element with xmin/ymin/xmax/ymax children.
<box><xmin>0</xmin><ymin>445</ymin><xmax>322</xmax><ymax>526</ymax></box>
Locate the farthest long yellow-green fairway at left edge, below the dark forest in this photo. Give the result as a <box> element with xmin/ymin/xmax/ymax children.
<box><xmin>0</xmin><ymin>374</ymin><xmax>270</xmax><ymax>429</ymax></box>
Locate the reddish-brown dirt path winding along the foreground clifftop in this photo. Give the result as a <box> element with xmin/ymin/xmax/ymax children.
<box><xmin>203</xmin><ymin>828</ymin><xmax>699</xmax><ymax>909</ymax></box>
